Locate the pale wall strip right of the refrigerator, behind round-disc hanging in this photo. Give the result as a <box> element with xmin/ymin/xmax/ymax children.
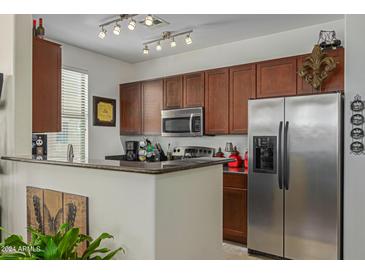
<box><xmin>344</xmin><ymin>15</ymin><xmax>365</xmax><ymax>260</ymax></box>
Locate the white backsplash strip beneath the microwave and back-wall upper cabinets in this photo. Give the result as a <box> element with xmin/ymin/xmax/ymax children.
<box><xmin>120</xmin><ymin>135</ymin><xmax>248</xmax><ymax>157</ymax></box>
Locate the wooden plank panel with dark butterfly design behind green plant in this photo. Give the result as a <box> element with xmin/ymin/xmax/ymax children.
<box><xmin>27</xmin><ymin>187</ymin><xmax>89</xmax><ymax>253</ymax></box>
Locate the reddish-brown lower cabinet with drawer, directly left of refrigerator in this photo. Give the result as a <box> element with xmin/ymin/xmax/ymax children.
<box><xmin>223</xmin><ymin>173</ymin><xmax>247</xmax><ymax>244</ymax></box>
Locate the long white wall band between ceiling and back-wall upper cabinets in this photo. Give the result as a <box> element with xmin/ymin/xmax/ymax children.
<box><xmin>131</xmin><ymin>20</ymin><xmax>344</xmax><ymax>80</ymax></box>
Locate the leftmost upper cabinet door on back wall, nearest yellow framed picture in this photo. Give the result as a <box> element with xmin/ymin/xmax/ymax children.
<box><xmin>120</xmin><ymin>83</ymin><xmax>142</xmax><ymax>135</ymax></box>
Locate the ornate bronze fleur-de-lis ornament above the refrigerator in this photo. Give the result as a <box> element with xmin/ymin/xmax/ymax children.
<box><xmin>298</xmin><ymin>45</ymin><xmax>336</xmax><ymax>90</ymax></box>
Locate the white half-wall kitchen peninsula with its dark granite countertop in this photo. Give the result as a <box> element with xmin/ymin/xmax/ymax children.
<box><xmin>1</xmin><ymin>156</ymin><xmax>230</xmax><ymax>259</ymax></box>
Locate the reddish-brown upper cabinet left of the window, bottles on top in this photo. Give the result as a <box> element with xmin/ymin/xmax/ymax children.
<box><xmin>32</xmin><ymin>38</ymin><xmax>62</xmax><ymax>133</ymax></box>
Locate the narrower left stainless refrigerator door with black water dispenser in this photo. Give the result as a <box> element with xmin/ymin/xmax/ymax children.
<box><xmin>248</xmin><ymin>98</ymin><xmax>284</xmax><ymax>257</ymax></box>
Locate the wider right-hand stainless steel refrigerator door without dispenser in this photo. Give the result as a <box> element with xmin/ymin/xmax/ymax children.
<box><xmin>284</xmin><ymin>93</ymin><xmax>342</xmax><ymax>260</ymax></box>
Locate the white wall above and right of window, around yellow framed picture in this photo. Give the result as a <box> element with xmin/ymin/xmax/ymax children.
<box><xmin>61</xmin><ymin>43</ymin><xmax>132</xmax><ymax>159</ymax></box>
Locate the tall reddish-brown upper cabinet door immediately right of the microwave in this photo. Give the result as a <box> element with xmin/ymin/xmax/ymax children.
<box><xmin>205</xmin><ymin>68</ymin><xmax>229</xmax><ymax>134</ymax></box>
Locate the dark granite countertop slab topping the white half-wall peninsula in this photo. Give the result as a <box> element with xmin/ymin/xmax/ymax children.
<box><xmin>1</xmin><ymin>155</ymin><xmax>233</xmax><ymax>174</ymax></box>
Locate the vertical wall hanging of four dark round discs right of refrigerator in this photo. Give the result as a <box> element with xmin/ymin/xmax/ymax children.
<box><xmin>350</xmin><ymin>95</ymin><xmax>365</xmax><ymax>155</ymax></box>
